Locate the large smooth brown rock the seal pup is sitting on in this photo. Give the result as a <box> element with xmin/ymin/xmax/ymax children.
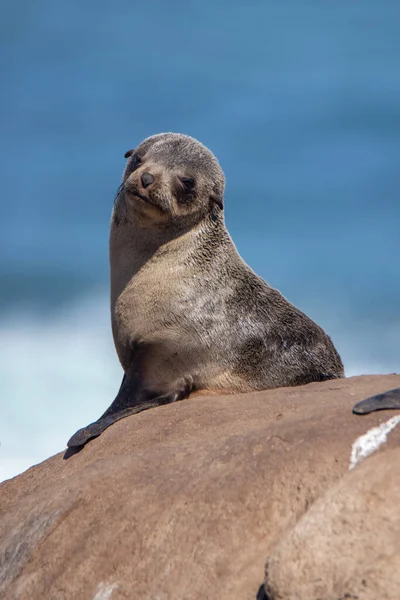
<box><xmin>0</xmin><ymin>375</ymin><xmax>400</xmax><ymax>600</ymax></box>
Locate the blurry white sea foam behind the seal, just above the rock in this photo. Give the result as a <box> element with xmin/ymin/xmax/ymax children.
<box><xmin>0</xmin><ymin>292</ymin><xmax>400</xmax><ymax>481</ymax></box>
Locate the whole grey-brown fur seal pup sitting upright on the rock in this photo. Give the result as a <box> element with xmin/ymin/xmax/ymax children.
<box><xmin>68</xmin><ymin>133</ymin><xmax>344</xmax><ymax>447</ymax></box>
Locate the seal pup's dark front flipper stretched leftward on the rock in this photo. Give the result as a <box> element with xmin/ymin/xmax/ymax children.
<box><xmin>67</xmin><ymin>375</ymin><xmax>191</xmax><ymax>448</ymax></box>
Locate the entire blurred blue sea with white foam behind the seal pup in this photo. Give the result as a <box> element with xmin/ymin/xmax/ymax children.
<box><xmin>0</xmin><ymin>0</ymin><xmax>400</xmax><ymax>480</ymax></box>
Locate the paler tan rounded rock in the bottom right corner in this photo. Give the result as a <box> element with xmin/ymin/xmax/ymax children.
<box><xmin>266</xmin><ymin>447</ymin><xmax>400</xmax><ymax>600</ymax></box>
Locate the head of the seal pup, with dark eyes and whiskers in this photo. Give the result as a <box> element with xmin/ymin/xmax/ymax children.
<box><xmin>119</xmin><ymin>133</ymin><xmax>225</xmax><ymax>227</ymax></box>
